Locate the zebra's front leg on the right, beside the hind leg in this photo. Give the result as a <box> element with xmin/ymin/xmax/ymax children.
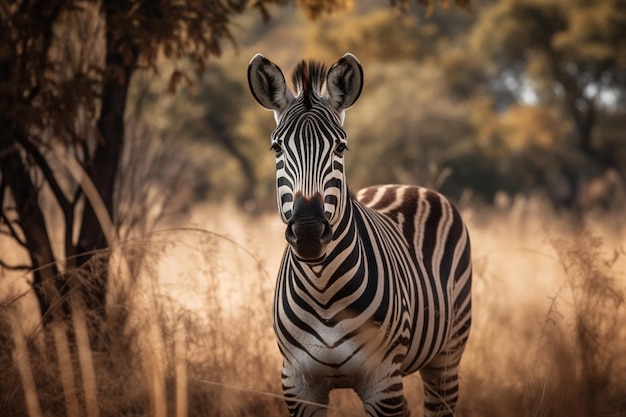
<box><xmin>355</xmin><ymin>371</ymin><xmax>409</xmax><ymax>417</ymax></box>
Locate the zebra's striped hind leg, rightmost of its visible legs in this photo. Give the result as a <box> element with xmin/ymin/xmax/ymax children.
<box><xmin>420</xmin><ymin>352</ymin><xmax>461</xmax><ymax>417</ymax></box>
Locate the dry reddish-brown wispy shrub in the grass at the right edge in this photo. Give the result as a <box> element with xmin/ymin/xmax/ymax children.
<box><xmin>535</xmin><ymin>230</ymin><xmax>626</xmax><ymax>416</ymax></box>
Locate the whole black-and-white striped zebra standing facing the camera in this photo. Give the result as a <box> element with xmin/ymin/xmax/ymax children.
<box><xmin>248</xmin><ymin>53</ymin><xmax>472</xmax><ymax>417</ymax></box>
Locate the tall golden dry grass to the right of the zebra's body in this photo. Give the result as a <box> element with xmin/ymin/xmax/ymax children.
<box><xmin>460</xmin><ymin>206</ymin><xmax>626</xmax><ymax>417</ymax></box>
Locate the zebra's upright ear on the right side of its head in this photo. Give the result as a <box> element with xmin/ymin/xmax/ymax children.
<box><xmin>326</xmin><ymin>54</ymin><xmax>363</xmax><ymax>111</ymax></box>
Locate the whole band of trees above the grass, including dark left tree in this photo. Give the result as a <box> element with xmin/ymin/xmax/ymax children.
<box><xmin>0</xmin><ymin>0</ymin><xmax>626</xmax><ymax>328</ymax></box>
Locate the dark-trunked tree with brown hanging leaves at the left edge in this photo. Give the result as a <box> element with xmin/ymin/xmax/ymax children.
<box><xmin>0</xmin><ymin>0</ymin><xmax>278</xmax><ymax>332</ymax></box>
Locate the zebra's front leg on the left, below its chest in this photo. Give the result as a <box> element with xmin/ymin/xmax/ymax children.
<box><xmin>281</xmin><ymin>364</ymin><xmax>329</xmax><ymax>417</ymax></box>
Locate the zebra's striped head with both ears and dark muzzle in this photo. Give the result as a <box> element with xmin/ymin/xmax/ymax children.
<box><xmin>248</xmin><ymin>54</ymin><xmax>363</xmax><ymax>262</ymax></box>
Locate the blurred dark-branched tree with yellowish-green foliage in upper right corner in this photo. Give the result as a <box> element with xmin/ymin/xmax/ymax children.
<box><xmin>472</xmin><ymin>0</ymin><xmax>626</xmax><ymax>207</ymax></box>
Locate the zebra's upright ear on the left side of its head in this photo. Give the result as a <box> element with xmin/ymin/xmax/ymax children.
<box><xmin>248</xmin><ymin>54</ymin><xmax>294</xmax><ymax>115</ymax></box>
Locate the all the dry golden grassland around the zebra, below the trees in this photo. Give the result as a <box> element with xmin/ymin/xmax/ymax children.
<box><xmin>0</xmin><ymin>200</ymin><xmax>626</xmax><ymax>417</ymax></box>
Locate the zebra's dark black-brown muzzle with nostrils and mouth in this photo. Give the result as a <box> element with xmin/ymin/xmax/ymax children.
<box><xmin>285</xmin><ymin>195</ymin><xmax>333</xmax><ymax>261</ymax></box>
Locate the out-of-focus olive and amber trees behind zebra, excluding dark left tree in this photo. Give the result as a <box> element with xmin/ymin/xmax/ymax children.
<box><xmin>127</xmin><ymin>0</ymin><xmax>626</xmax><ymax>214</ymax></box>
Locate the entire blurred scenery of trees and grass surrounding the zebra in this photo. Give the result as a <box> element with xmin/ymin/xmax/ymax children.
<box><xmin>0</xmin><ymin>0</ymin><xmax>626</xmax><ymax>417</ymax></box>
